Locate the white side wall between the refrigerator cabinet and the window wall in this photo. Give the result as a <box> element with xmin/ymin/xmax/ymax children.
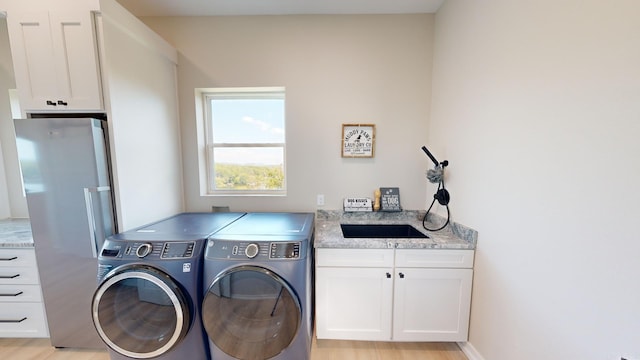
<box><xmin>101</xmin><ymin>1</ymin><xmax>184</xmax><ymax>231</ymax></box>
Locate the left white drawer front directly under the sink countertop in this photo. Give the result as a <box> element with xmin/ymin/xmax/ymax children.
<box><xmin>316</xmin><ymin>249</ymin><xmax>393</xmax><ymax>267</ymax></box>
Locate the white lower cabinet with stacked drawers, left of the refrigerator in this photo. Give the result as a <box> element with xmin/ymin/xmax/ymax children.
<box><xmin>0</xmin><ymin>248</ymin><xmax>49</xmax><ymax>338</ymax></box>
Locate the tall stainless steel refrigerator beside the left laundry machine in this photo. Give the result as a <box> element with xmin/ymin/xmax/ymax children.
<box><xmin>14</xmin><ymin>118</ymin><xmax>117</xmax><ymax>349</ymax></box>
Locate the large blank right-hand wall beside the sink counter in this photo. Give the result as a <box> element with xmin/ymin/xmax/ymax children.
<box><xmin>429</xmin><ymin>0</ymin><xmax>640</xmax><ymax>360</ymax></box>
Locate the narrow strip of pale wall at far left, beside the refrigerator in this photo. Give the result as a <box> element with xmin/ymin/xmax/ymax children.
<box><xmin>0</xmin><ymin>17</ymin><xmax>29</xmax><ymax>219</ymax></box>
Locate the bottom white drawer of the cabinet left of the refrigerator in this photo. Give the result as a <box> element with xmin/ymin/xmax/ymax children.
<box><xmin>0</xmin><ymin>303</ymin><xmax>49</xmax><ymax>338</ymax></box>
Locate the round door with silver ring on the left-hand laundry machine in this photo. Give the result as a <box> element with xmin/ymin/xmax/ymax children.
<box><xmin>92</xmin><ymin>265</ymin><xmax>192</xmax><ymax>359</ymax></box>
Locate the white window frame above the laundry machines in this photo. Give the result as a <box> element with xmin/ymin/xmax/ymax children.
<box><xmin>196</xmin><ymin>87</ymin><xmax>287</xmax><ymax>196</ymax></box>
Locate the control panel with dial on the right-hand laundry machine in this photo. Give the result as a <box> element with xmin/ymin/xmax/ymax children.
<box><xmin>205</xmin><ymin>239</ymin><xmax>302</xmax><ymax>260</ymax></box>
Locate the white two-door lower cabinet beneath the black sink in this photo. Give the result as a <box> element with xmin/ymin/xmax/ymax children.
<box><xmin>316</xmin><ymin>248</ymin><xmax>474</xmax><ymax>341</ymax></box>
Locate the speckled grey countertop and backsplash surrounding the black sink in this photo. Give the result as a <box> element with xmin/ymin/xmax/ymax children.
<box><xmin>314</xmin><ymin>210</ymin><xmax>478</xmax><ymax>250</ymax></box>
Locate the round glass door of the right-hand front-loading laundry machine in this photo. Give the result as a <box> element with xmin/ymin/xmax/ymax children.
<box><xmin>201</xmin><ymin>266</ymin><xmax>302</xmax><ymax>360</ymax></box>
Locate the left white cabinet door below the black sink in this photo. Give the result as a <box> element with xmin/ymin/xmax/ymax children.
<box><xmin>316</xmin><ymin>267</ymin><xmax>393</xmax><ymax>341</ymax></box>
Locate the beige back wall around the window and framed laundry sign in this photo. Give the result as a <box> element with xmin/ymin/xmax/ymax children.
<box><xmin>142</xmin><ymin>15</ymin><xmax>433</xmax><ymax>211</ymax></box>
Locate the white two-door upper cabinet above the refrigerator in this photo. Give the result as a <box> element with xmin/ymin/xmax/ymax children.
<box><xmin>7</xmin><ymin>9</ymin><xmax>103</xmax><ymax>112</ymax></box>
